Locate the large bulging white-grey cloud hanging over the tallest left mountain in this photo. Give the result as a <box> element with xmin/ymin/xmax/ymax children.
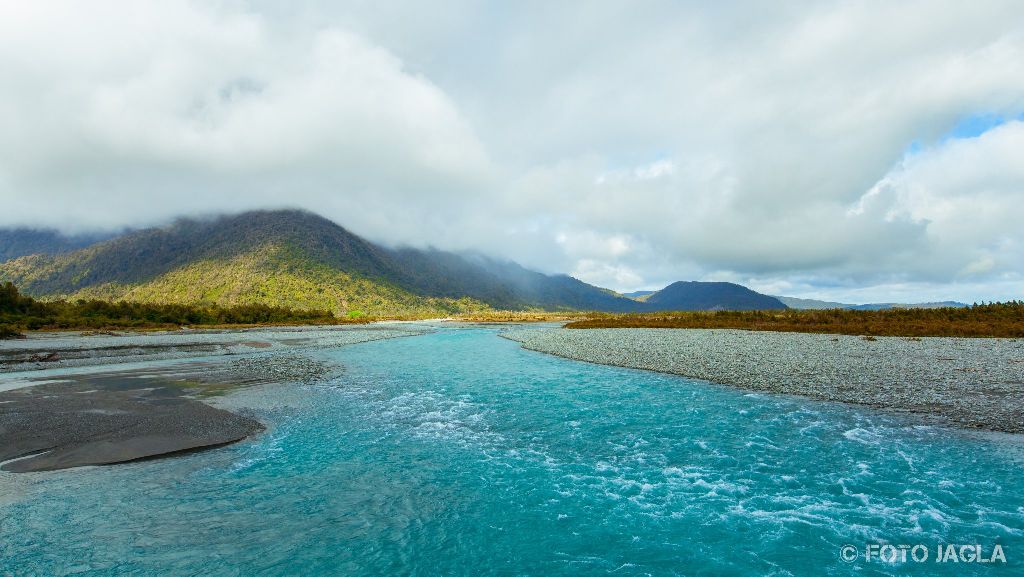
<box><xmin>0</xmin><ymin>2</ymin><xmax>489</xmax><ymax>234</ymax></box>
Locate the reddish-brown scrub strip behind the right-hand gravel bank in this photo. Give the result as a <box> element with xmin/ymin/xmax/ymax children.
<box><xmin>565</xmin><ymin>300</ymin><xmax>1024</xmax><ymax>338</ymax></box>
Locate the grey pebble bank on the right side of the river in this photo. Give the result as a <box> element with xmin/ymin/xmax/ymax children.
<box><xmin>502</xmin><ymin>329</ymin><xmax>1024</xmax><ymax>434</ymax></box>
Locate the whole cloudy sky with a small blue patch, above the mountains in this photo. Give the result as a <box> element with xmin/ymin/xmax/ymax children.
<box><xmin>0</xmin><ymin>0</ymin><xmax>1024</xmax><ymax>302</ymax></box>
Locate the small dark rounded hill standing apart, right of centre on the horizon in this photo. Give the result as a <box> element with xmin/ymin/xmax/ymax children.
<box><xmin>643</xmin><ymin>281</ymin><xmax>786</xmax><ymax>311</ymax></box>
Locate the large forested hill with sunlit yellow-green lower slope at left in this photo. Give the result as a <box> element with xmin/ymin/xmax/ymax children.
<box><xmin>0</xmin><ymin>211</ymin><xmax>490</xmax><ymax>316</ymax></box>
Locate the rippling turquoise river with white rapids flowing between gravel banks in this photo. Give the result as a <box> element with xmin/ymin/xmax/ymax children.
<box><xmin>0</xmin><ymin>328</ymin><xmax>1024</xmax><ymax>576</ymax></box>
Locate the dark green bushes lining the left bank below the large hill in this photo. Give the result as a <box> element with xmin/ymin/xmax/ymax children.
<box><xmin>0</xmin><ymin>283</ymin><xmax>352</xmax><ymax>338</ymax></box>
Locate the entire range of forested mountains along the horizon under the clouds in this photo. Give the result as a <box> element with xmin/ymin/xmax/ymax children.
<box><xmin>0</xmin><ymin>210</ymin><xmax>966</xmax><ymax>316</ymax></box>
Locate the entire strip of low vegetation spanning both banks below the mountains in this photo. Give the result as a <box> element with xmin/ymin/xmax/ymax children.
<box><xmin>0</xmin><ymin>274</ymin><xmax>1024</xmax><ymax>338</ymax></box>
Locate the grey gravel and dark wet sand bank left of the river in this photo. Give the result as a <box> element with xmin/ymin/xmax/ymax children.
<box><xmin>0</xmin><ymin>326</ymin><xmax>424</xmax><ymax>472</ymax></box>
